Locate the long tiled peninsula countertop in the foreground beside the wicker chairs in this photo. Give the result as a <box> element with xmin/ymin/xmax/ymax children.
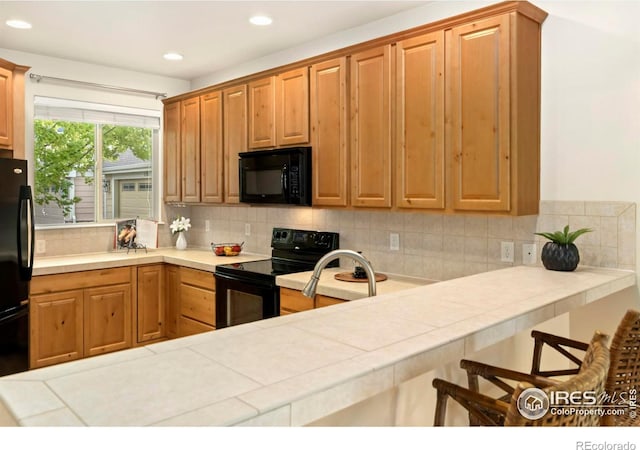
<box><xmin>0</xmin><ymin>266</ymin><xmax>636</xmax><ymax>426</ymax></box>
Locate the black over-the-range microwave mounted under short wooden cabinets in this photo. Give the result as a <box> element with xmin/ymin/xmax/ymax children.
<box><xmin>239</xmin><ymin>147</ymin><xmax>311</xmax><ymax>206</ymax></box>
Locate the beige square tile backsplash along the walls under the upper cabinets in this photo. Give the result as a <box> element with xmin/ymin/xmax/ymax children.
<box><xmin>36</xmin><ymin>201</ymin><xmax>636</xmax><ymax>280</ymax></box>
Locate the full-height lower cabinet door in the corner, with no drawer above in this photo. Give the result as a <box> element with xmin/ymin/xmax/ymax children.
<box><xmin>136</xmin><ymin>264</ymin><xmax>165</xmax><ymax>342</ymax></box>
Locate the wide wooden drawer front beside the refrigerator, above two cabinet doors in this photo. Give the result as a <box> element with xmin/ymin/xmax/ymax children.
<box><xmin>30</xmin><ymin>267</ymin><xmax>132</xmax><ymax>295</ymax></box>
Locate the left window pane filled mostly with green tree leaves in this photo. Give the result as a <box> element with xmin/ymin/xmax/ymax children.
<box><xmin>34</xmin><ymin>120</ymin><xmax>95</xmax><ymax>225</ymax></box>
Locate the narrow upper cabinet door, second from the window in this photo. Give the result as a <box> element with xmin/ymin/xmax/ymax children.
<box><xmin>180</xmin><ymin>97</ymin><xmax>200</xmax><ymax>203</ymax></box>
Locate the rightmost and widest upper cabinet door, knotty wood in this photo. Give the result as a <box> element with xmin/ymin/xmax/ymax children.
<box><xmin>446</xmin><ymin>15</ymin><xmax>511</xmax><ymax>211</ymax></box>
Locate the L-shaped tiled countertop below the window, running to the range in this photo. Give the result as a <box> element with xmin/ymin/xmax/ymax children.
<box><xmin>33</xmin><ymin>248</ymin><xmax>271</xmax><ymax>276</ymax></box>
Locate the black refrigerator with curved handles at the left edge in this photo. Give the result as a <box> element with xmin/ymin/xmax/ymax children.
<box><xmin>0</xmin><ymin>158</ymin><xmax>35</xmax><ymax>376</ymax></box>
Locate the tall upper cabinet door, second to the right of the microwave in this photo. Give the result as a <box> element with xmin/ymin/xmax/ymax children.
<box><xmin>351</xmin><ymin>45</ymin><xmax>391</xmax><ymax>207</ymax></box>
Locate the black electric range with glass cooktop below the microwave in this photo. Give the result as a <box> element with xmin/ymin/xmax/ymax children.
<box><xmin>215</xmin><ymin>228</ymin><xmax>340</xmax><ymax>328</ymax></box>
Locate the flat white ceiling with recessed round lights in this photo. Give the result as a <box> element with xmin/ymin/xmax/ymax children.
<box><xmin>0</xmin><ymin>0</ymin><xmax>428</xmax><ymax>80</ymax></box>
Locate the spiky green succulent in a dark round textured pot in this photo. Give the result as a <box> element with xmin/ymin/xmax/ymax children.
<box><xmin>535</xmin><ymin>225</ymin><xmax>593</xmax><ymax>272</ymax></box>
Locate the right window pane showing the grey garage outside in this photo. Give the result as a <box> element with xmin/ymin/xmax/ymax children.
<box><xmin>101</xmin><ymin>125</ymin><xmax>153</xmax><ymax>219</ymax></box>
